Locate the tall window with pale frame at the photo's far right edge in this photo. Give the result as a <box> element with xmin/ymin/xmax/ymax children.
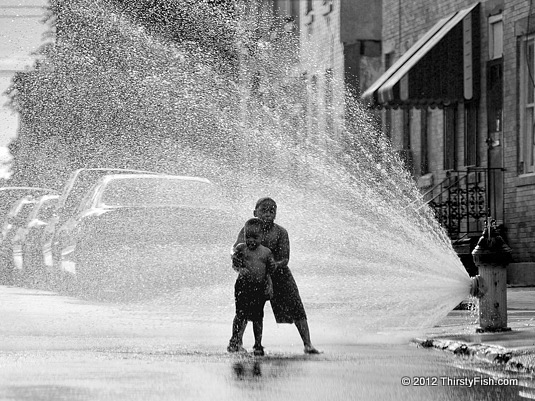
<box><xmin>519</xmin><ymin>36</ymin><xmax>535</xmax><ymax>174</ymax></box>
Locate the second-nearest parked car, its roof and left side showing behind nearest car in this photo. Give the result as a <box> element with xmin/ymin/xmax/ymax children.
<box><xmin>41</xmin><ymin>168</ymin><xmax>162</xmax><ymax>273</ymax></box>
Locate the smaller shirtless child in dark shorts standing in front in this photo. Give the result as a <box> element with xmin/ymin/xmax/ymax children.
<box><xmin>227</xmin><ymin>218</ymin><xmax>275</xmax><ymax>355</ymax></box>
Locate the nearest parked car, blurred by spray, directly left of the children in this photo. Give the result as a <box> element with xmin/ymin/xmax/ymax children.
<box><xmin>57</xmin><ymin>174</ymin><xmax>239</xmax><ymax>295</ymax></box>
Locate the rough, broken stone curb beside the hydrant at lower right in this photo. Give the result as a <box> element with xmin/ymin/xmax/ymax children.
<box><xmin>411</xmin><ymin>338</ymin><xmax>535</xmax><ymax>374</ymax></box>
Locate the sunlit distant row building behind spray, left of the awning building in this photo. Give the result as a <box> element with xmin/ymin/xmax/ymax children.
<box><xmin>300</xmin><ymin>0</ymin><xmax>382</xmax><ymax>148</ymax></box>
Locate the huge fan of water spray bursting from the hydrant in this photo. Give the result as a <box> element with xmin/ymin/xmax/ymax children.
<box><xmin>14</xmin><ymin>1</ymin><xmax>470</xmax><ymax>337</ymax></box>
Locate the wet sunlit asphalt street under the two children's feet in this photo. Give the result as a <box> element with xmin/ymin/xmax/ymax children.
<box><xmin>0</xmin><ymin>286</ymin><xmax>535</xmax><ymax>401</ymax></box>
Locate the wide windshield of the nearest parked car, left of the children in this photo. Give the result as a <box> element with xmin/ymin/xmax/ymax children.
<box><xmin>100</xmin><ymin>178</ymin><xmax>228</xmax><ymax>208</ymax></box>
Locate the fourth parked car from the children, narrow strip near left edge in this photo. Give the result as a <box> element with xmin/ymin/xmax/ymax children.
<box><xmin>0</xmin><ymin>195</ymin><xmax>42</xmax><ymax>284</ymax></box>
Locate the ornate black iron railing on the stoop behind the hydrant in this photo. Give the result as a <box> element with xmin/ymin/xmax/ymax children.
<box><xmin>424</xmin><ymin>167</ymin><xmax>503</xmax><ymax>240</ymax></box>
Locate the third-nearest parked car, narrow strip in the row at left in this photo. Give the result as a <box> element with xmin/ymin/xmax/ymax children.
<box><xmin>11</xmin><ymin>195</ymin><xmax>59</xmax><ymax>288</ymax></box>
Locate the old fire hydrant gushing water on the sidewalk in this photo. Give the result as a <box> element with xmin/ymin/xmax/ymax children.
<box><xmin>470</xmin><ymin>220</ymin><xmax>512</xmax><ymax>333</ymax></box>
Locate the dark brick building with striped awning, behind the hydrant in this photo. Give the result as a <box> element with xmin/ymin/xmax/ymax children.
<box><xmin>362</xmin><ymin>0</ymin><xmax>535</xmax><ymax>284</ymax></box>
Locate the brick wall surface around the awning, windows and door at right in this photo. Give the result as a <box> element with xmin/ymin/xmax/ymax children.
<box><xmin>383</xmin><ymin>0</ymin><xmax>535</xmax><ymax>262</ymax></box>
